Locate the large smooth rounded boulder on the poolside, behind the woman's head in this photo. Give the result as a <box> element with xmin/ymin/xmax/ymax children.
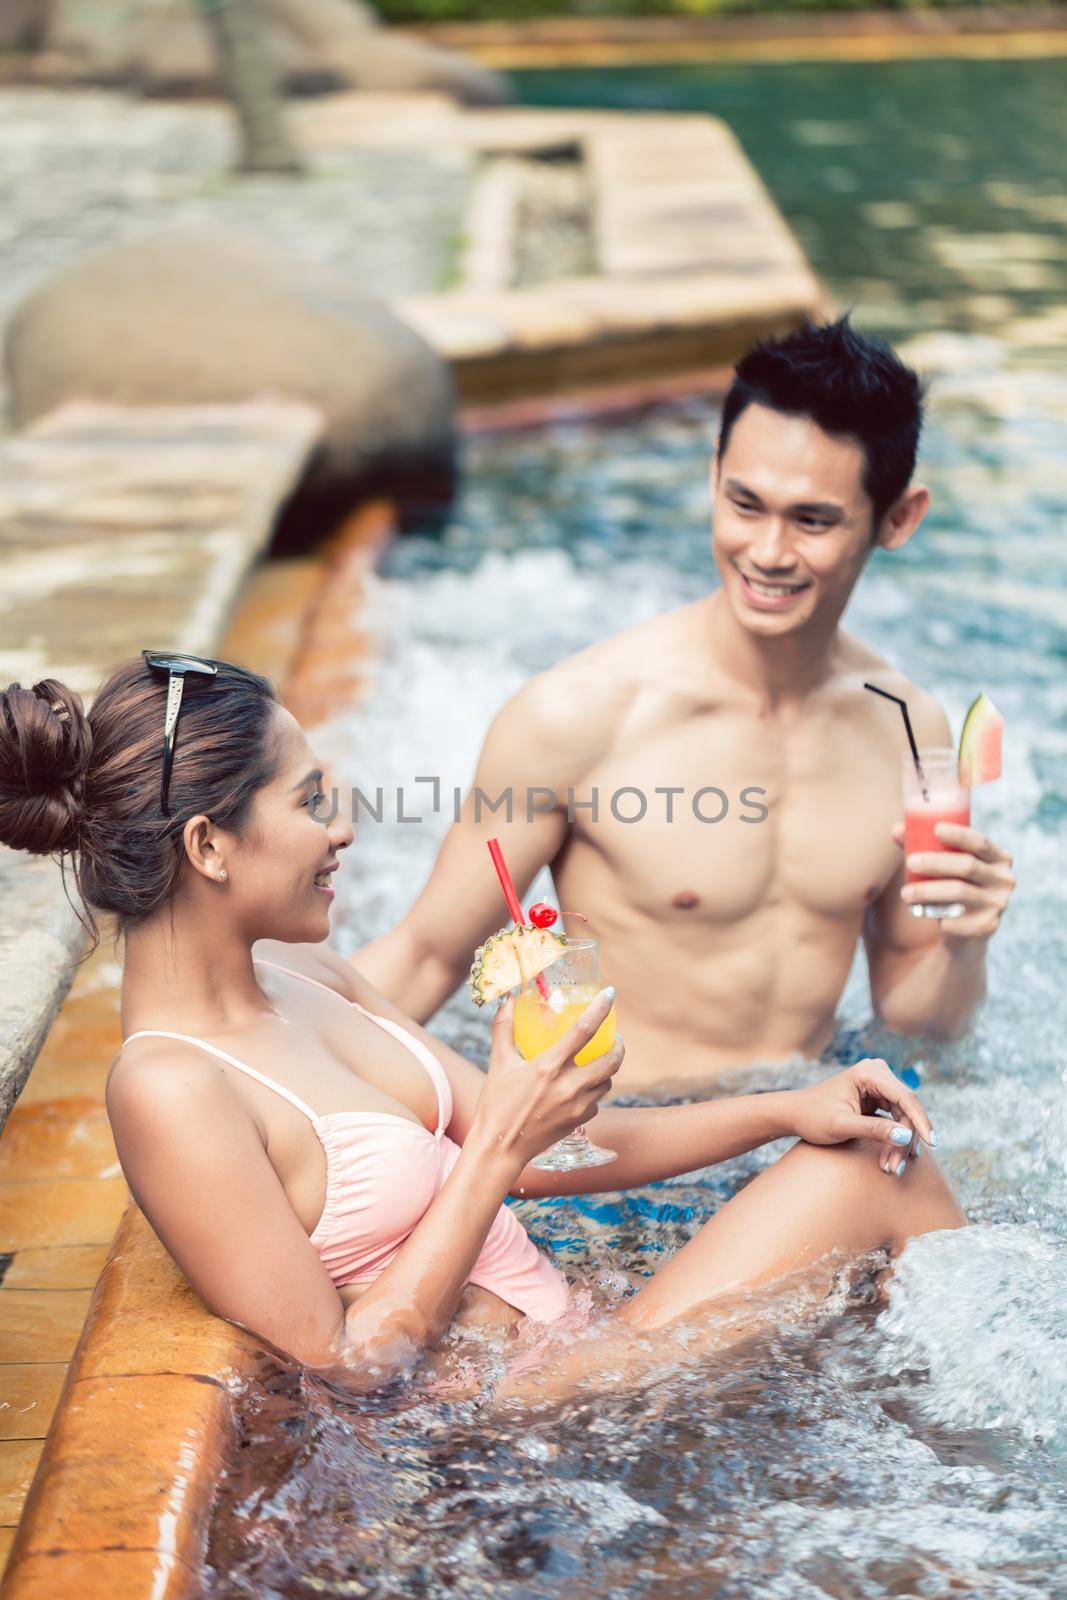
<box><xmin>5</xmin><ymin>229</ymin><xmax>456</xmax><ymax>549</ymax></box>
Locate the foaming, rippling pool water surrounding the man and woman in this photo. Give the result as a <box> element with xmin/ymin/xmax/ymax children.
<box><xmin>205</xmin><ymin>64</ymin><xmax>1067</xmax><ymax>1600</ymax></box>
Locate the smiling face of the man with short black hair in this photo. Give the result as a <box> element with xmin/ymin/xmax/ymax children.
<box><xmin>712</xmin><ymin>405</ymin><xmax>872</xmax><ymax>638</ymax></box>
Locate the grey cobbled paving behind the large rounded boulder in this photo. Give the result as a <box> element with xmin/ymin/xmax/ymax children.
<box><xmin>0</xmin><ymin>88</ymin><xmax>470</xmax><ymax>422</ymax></box>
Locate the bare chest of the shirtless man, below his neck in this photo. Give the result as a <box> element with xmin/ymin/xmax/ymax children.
<box><xmin>568</xmin><ymin>714</ymin><xmax>899</xmax><ymax>923</ymax></box>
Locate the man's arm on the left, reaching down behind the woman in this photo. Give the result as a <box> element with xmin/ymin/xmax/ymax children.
<box><xmin>352</xmin><ymin>669</ymin><xmax>582</xmax><ymax>1022</ymax></box>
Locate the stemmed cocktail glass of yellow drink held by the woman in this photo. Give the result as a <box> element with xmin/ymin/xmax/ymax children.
<box><xmin>515</xmin><ymin>939</ymin><xmax>616</xmax><ymax>1173</ymax></box>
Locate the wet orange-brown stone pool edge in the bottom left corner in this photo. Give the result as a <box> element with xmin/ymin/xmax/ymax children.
<box><xmin>3</xmin><ymin>1203</ymin><xmax>261</xmax><ymax>1600</ymax></box>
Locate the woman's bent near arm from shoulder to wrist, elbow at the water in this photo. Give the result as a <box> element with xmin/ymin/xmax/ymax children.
<box><xmin>109</xmin><ymin>1058</ymin><xmax>523</xmax><ymax>1381</ymax></box>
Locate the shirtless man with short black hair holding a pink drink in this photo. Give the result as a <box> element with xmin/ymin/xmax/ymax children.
<box><xmin>354</xmin><ymin>318</ymin><xmax>1014</xmax><ymax>1091</ymax></box>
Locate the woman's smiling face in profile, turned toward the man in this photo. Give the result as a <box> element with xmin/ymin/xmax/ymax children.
<box><xmin>217</xmin><ymin>706</ymin><xmax>352</xmax><ymax>944</ymax></box>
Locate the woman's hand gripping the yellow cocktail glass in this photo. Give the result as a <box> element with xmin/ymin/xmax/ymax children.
<box><xmin>470</xmin><ymin>989</ymin><xmax>625</xmax><ymax>1173</ymax></box>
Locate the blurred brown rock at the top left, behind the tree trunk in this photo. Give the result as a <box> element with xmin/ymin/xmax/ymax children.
<box><xmin>46</xmin><ymin>0</ymin><xmax>510</xmax><ymax>106</ymax></box>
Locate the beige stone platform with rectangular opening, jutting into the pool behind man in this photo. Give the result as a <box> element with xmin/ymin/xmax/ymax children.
<box><xmin>293</xmin><ymin>94</ymin><xmax>829</xmax><ymax>405</ymax></box>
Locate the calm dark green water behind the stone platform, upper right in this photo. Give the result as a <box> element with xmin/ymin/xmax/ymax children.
<box><xmin>515</xmin><ymin>61</ymin><xmax>1067</xmax><ymax>360</ymax></box>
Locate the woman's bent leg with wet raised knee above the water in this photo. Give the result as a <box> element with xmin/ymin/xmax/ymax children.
<box><xmin>617</xmin><ymin>1139</ymin><xmax>966</xmax><ymax>1330</ymax></box>
